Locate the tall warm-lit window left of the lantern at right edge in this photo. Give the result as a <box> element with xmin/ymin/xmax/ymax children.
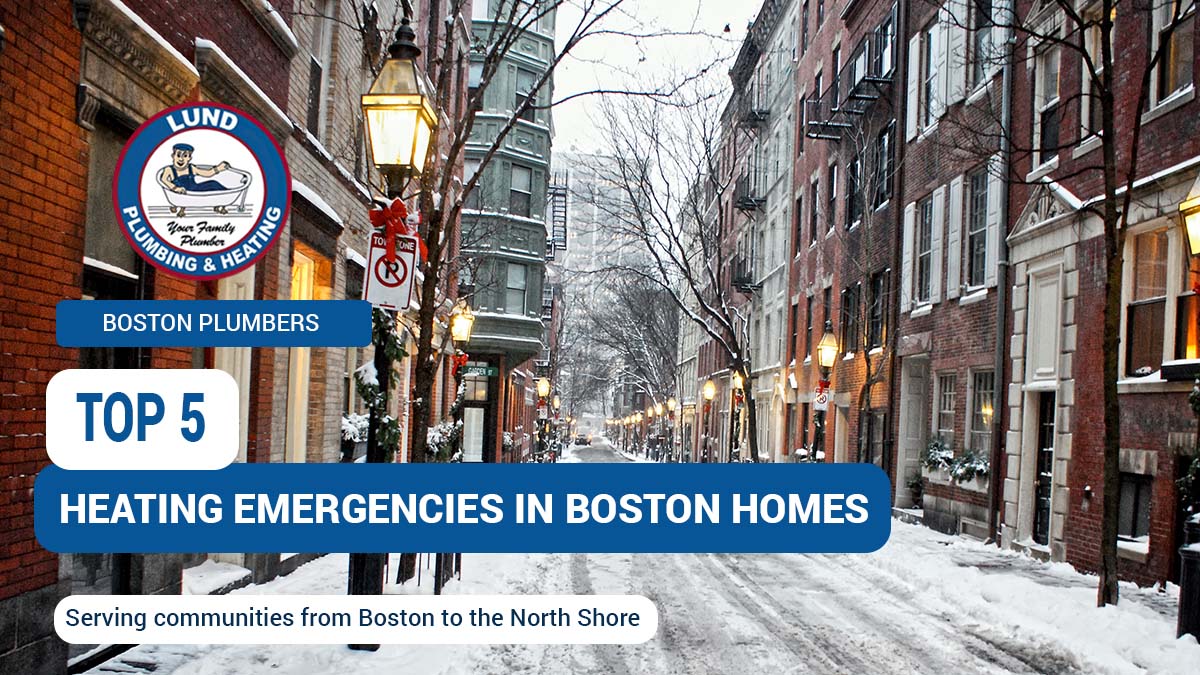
<box><xmin>1124</xmin><ymin>229</ymin><xmax>1168</xmax><ymax>377</ymax></box>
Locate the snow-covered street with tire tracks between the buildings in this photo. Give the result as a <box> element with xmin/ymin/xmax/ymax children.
<box><xmin>92</xmin><ymin>438</ymin><xmax>1200</xmax><ymax>675</ymax></box>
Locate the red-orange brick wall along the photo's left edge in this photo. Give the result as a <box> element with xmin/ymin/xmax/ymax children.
<box><xmin>0</xmin><ymin>2</ymin><xmax>88</xmax><ymax>599</ymax></box>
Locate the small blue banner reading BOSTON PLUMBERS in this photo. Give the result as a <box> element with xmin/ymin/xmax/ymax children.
<box><xmin>56</xmin><ymin>300</ymin><xmax>371</xmax><ymax>347</ymax></box>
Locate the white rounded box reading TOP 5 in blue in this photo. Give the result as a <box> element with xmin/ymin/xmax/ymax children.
<box><xmin>46</xmin><ymin>369</ymin><xmax>241</xmax><ymax>470</ymax></box>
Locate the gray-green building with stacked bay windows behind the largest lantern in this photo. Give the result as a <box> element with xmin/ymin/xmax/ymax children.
<box><xmin>462</xmin><ymin>0</ymin><xmax>554</xmax><ymax>461</ymax></box>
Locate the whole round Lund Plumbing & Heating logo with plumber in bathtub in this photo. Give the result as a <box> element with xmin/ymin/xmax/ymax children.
<box><xmin>113</xmin><ymin>103</ymin><xmax>292</xmax><ymax>279</ymax></box>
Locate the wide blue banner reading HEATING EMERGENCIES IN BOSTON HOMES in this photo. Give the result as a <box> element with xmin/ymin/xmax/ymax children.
<box><xmin>34</xmin><ymin>464</ymin><xmax>892</xmax><ymax>552</ymax></box>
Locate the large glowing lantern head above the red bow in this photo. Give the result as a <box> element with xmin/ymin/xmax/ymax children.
<box><xmin>362</xmin><ymin>18</ymin><xmax>438</xmax><ymax>193</ymax></box>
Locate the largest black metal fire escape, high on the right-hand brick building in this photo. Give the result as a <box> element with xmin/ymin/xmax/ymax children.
<box><xmin>804</xmin><ymin>23</ymin><xmax>895</xmax><ymax>142</ymax></box>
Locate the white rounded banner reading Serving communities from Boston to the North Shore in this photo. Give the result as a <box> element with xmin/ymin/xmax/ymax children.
<box><xmin>54</xmin><ymin>593</ymin><xmax>659</xmax><ymax>645</ymax></box>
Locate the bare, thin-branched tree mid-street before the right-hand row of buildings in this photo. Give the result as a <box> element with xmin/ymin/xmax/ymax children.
<box><xmin>583</xmin><ymin>85</ymin><xmax>758</xmax><ymax>461</ymax></box>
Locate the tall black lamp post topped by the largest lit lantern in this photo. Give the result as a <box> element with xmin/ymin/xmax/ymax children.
<box><xmin>348</xmin><ymin>16</ymin><xmax>437</xmax><ymax>651</ymax></box>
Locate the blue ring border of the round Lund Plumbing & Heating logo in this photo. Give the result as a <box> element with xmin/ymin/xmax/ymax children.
<box><xmin>113</xmin><ymin>102</ymin><xmax>292</xmax><ymax>281</ymax></box>
